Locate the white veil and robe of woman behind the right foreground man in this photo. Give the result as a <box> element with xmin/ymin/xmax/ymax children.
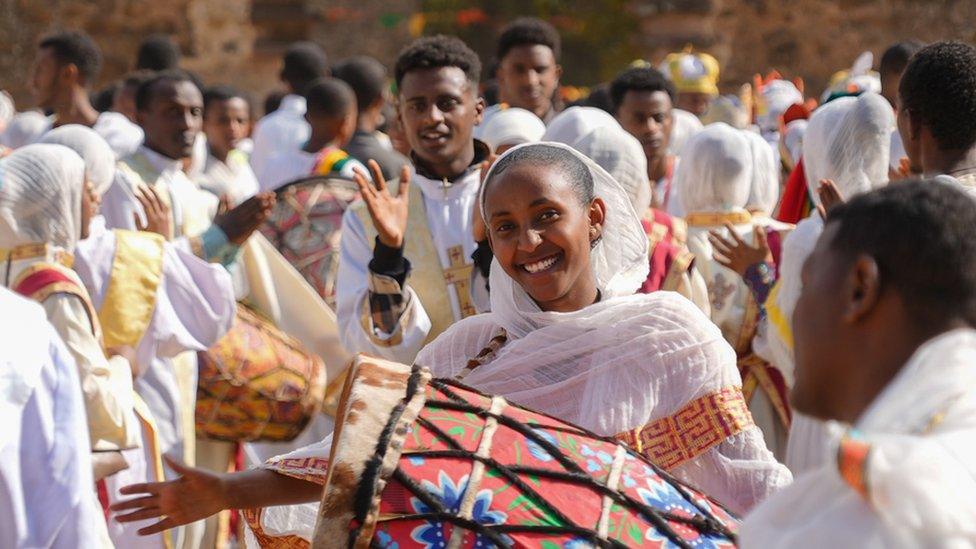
<box><xmin>755</xmin><ymin>93</ymin><xmax>895</xmax><ymax>385</ymax></box>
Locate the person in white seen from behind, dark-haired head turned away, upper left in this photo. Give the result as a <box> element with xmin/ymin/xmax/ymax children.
<box><xmin>251</xmin><ymin>42</ymin><xmax>329</xmax><ymax>179</ymax></box>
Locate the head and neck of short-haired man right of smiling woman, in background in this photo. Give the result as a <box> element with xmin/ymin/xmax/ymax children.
<box><xmin>610</xmin><ymin>67</ymin><xmax>675</xmax><ymax>211</ymax></box>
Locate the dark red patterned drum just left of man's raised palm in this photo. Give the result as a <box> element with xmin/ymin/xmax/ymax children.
<box><xmin>260</xmin><ymin>176</ymin><xmax>359</xmax><ymax>310</ymax></box>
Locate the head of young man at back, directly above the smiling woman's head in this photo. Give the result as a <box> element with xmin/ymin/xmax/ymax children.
<box><xmin>475</xmin><ymin>17</ymin><xmax>563</xmax><ymax>138</ymax></box>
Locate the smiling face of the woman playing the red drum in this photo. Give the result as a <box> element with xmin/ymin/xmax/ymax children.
<box><xmin>485</xmin><ymin>164</ymin><xmax>606</xmax><ymax>312</ymax></box>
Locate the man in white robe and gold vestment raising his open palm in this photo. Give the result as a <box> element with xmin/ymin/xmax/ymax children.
<box><xmin>337</xmin><ymin>36</ymin><xmax>488</xmax><ymax>363</ymax></box>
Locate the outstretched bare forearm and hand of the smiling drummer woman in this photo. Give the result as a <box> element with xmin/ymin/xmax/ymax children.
<box><xmin>111</xmin><ymin>456</ymin><xmax>322</xmax><ymax>536</ymax></box>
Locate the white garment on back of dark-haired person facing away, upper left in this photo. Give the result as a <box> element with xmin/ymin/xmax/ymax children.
<box><xmin>251</xmin><ymin>94</ymin><xmax>312</xmax><ymax>180</ymax></box>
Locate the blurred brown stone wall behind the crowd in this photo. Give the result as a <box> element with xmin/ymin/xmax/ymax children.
<box><xmin>0</xmin><ymin>0</ymin><xmax>976</xmax><ymax>111</ymax></box>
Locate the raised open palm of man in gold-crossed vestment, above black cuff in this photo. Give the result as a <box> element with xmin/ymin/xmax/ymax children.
<box><xmin>353</xmin><ymin>160</ymin><xmax>410</xmax><ymax>248</ymax></box>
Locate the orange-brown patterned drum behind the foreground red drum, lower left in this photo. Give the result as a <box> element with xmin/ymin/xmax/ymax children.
<box><xmin>196</xmin><ymin>304</ymin><xmax>326</xmax><ymax>442</ymax></box>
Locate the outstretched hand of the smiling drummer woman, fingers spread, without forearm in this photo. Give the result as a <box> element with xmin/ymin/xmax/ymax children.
<box><xmin>111</xmin><ymin>456</ymin><xmax>228</xmax><ymax>536</ymax></box>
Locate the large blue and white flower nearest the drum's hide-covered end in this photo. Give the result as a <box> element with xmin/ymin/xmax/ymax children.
<box><xmin>410</xmin><ymin>471</ymin><xmax>508</xmax><ymax>549</ymax></box>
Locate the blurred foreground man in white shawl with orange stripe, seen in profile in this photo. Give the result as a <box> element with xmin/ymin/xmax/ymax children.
<box><xmin>740</xmin><ymin>180</ymin><xmax>976</xmax><ymax>548</ymax></box>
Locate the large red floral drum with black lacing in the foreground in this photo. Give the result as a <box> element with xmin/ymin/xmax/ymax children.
<box><xmin>314</xmin><ymin>358</ymin><xmax>738</xmax><ymax>549</ymax></box>
